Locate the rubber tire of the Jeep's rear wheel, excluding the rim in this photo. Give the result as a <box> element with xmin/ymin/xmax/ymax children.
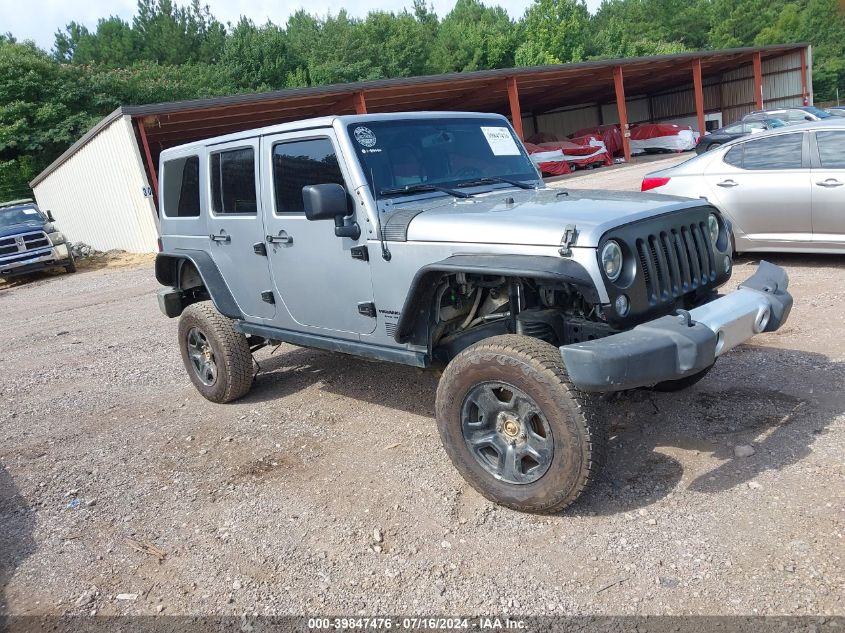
<box><xmin>179</xmin><ymin>301</ymin><xmax>254</xmax><ymax>403</ymax></box>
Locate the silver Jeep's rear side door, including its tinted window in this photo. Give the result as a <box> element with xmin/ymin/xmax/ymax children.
<box><xmin>206</xmin><ymin>139</ymin><xmax>276</xmax><ymax>319</ymax></box>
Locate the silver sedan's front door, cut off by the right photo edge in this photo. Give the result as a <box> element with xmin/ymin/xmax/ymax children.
<box><xmin>810</xmin><ymin>130</ymin><xmax>845</xmax><ymax>244</ymax></box>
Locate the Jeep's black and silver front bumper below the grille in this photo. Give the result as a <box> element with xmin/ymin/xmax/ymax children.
<box><xmin>560</xmin><ymin>261</ymin><xmax>792</xmax><ymax>392</ymax></box>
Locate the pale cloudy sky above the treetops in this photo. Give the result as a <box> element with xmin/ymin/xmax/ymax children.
<box><xmin>0</xmin><ymin>0</ymin><xmax>601</xmax><ymax>50</ymax></box>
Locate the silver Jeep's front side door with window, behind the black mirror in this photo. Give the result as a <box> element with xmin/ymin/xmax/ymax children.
<box><xmin>261</xmin><ymin>130</ymin><xmax>376</xmax><ymax>338</ymax></box>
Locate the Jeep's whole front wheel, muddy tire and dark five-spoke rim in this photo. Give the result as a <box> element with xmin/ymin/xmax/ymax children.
<box><xmin>437</xmin><ymin>335</ymin><xmax>607</xmax><ymax>513</ymax></box>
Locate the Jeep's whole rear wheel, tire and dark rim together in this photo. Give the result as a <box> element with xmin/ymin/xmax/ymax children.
<box><xmin>179</xmin><ymin>301</ymin><xmax>253</xmax><ymax>403</ymax></box>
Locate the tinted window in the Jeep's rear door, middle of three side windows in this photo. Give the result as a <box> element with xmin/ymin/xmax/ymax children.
<box><xmin>211</xmin><ymin>147</ymin><xmax>258</xmax><ymax>214</ymax></box>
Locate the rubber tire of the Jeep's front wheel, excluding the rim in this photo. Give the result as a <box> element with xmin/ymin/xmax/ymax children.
<box><xmin>436</xmin><ymin>334</ymin><xmax>608</xmax><ymax>513</ymax></box>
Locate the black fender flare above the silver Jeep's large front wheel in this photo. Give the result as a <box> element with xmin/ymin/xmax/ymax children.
<box><xmin>395</xmin><ymin>255</ymin><xmax>600</xmax><ymax>345</ymax></box>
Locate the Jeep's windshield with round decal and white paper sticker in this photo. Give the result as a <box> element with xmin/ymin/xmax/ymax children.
<box><xmin>348</xmin><ymin>117</ymin><xmax>540</xmax><ymax>195</ymax></box>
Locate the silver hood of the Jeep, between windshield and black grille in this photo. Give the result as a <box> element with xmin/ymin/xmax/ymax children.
<box><xmin>394</xmin><ymin>189</ymin><xmax>707</xmax><ymax>247</ymax></box>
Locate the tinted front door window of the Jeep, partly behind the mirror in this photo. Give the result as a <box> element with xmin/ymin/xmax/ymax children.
<box><xmin>273</xmin><ymin>138</ymin><xmax>344</xmax><ymax>213</ymax></box>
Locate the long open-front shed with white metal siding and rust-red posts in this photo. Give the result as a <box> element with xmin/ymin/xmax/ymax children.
<box><xmin>30</xmin><ymin>44</ymin><xmax>812</xmax><ymax>252</ymax></box>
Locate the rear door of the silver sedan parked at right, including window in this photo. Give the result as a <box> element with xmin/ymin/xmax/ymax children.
<box><xmin>705</xmin><ymin>132</ymin><xmax>812</xmax><ymax>242</ymax></box>
